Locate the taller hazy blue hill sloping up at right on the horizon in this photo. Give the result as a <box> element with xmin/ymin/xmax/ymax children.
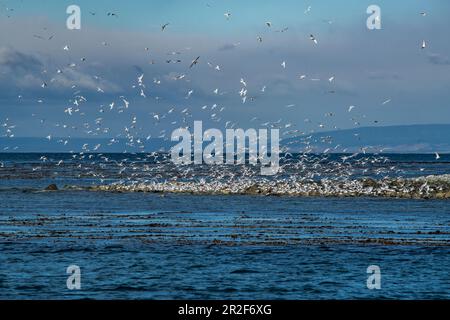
<box><xmin>281</xmin><ymin>124</ymin><xmax>450</xmax><ymax>153</ymax></box>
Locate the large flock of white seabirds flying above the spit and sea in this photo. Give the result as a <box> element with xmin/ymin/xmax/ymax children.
<box><xmin>1</xmin><ymin>6</ymin><xmax>440</xmax><ymax>192</ymax></box>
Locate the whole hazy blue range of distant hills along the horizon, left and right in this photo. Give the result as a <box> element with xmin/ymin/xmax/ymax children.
<box><xmin>0</xmin><ymin>124</ymin><xmax>450</xmax><ymax>153</ymax></box>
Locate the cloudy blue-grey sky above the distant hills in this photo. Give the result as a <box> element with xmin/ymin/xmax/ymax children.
<box><xmin>0</xmin><ymin>0</ymin><xmax>450</xmax><ymax>142</ymax></box>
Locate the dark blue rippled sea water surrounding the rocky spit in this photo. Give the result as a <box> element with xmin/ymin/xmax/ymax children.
<box><xmin>0</xmin><ymin>154</ymin><xmax>450</xmax><ymax>299</ymax></box>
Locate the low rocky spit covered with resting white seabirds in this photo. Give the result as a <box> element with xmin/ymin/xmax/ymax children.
<box><xmin>74</xmin><ymin>174</ymin><xmax>450</xmax><ymax>199</ymax></box>
